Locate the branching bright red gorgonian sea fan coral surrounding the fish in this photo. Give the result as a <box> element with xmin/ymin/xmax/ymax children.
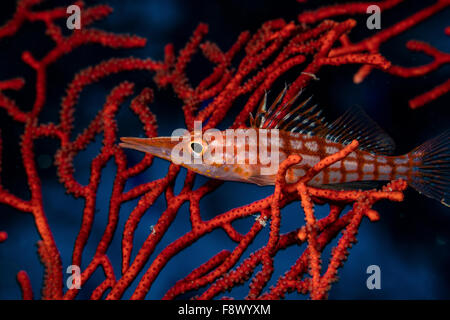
<box><xmin>0</xmin><ymin>0</ymin><xmax>450</xmax><ymax>299</ymax></box>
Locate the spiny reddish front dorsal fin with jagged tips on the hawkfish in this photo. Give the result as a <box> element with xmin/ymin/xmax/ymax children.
<box><xmin>250</xmin><ymin>86</ymin><xmax>326</xmax><ymax>135</ymax></box>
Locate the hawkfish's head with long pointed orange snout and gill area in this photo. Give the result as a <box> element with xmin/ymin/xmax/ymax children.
<box><xmin>120</xmin><ymin>130</ymin><xmax>277</xmax><ymax>185</ymax></box>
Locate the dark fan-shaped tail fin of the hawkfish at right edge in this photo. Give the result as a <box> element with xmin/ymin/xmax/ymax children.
<box><xmin>410</xmin><ymin>130</ymin><xmax>450</xmax><ymax>207</ymax></box>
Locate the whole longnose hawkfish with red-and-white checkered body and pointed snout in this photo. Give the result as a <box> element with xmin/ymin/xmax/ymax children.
<box><xmin>120</xmin><ymin>86</ymin><xmax>450</xmax><ymax>206</ymax></box>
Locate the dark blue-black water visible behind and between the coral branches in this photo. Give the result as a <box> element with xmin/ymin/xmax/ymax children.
<box><xmin>0</xmin><ymin>0</ymin><xmax>450</xmax><ymax>299</ymax></box>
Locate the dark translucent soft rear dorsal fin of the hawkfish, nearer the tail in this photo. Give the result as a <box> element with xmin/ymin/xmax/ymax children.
<box><xmin>318</xmin><ymin>106</ymin><xmax>395</xmax><ymax>155</ymax></box>
